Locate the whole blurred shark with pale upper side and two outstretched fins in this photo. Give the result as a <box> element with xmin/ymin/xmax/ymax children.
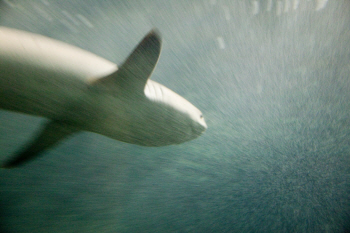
<box><xmin>0</xmin><ymin>27</ymin><xmax>207</xmax><ymax>168</ymax></box>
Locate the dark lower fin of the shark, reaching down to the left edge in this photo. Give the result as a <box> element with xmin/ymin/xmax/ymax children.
<box><xmin>2</xmin><ymin>121</ymin><xmax>78</xmax><ymax>168</ymax></box>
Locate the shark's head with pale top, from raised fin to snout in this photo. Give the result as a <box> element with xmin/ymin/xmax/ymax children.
<box><xmin>131</xmin><ymin>81</ymin><xmax>207</xmax><ymax>146</ymax></box>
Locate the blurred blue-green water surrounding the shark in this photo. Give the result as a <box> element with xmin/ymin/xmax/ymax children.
<box><xmin>0</xmin><ymin>0</ymin><xmax>350</xmax><ymax>233</ymax></box>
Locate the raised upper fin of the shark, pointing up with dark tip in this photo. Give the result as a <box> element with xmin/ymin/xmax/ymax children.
<box><xmin>92</xmin><ymin>29</ymin><xmax>161</xmax><ymax>94</ymax></box>
